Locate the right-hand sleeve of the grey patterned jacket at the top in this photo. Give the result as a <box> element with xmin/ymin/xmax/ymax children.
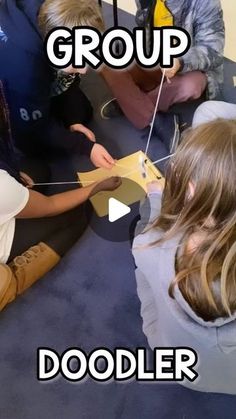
<box><xmin>182</xmin><ymin>0</ymin><xmax>225</xmax><ymax>72</ymax></box>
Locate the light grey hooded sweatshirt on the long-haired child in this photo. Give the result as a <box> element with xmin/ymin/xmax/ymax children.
<box><xmin>133</xmin><ymin>194</ymin><xmax>236</xmax><ymax>394</ymax></box>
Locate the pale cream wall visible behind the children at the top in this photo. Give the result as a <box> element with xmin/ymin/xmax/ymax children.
<box><xmin>105</xmin><ymin>0</ymin><xmax>236</xmax><ymax>61</ymax></box>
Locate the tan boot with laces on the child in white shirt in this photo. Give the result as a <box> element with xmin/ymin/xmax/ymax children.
<box><xmin>9</xmin><ymin>243</ymin><xmax>60</xmax><ymax>295</ymax></box>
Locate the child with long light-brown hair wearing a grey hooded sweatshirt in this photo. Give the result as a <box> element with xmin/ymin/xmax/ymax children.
<box><xmin>133</xmin><ymin>120</ymin><xmax>236</xmax><ymax>394</ymax></box>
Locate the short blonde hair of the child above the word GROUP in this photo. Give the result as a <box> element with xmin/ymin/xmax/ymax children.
<box><xmin>38</xmin><ymin>0</ymin><xmax>104</xmax><ymax>36</ymax></box>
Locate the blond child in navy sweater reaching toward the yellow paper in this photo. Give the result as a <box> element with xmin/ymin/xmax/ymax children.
<box><xmin>0</xmin><ymin>0</ymin><xmax>114</xmax><ymax>168</ymax></box>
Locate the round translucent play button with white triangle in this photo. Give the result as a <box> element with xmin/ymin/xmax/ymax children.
<box><xmin>87</xmin><ymin>178</ymin><xmax>150</xmax><ymax>242</ymax></box>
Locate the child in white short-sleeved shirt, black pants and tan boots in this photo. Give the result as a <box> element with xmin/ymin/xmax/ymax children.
<box><xmin>0</xmin><ymin>84</ymin><xmax>120</xmax><ymax>311</ymax></box>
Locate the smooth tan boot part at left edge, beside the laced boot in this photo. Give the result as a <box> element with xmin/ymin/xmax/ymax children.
<box><xmin>0</xmin><ymin>264</ymin><xmax>17</xmax><ymax>311</ymax></box>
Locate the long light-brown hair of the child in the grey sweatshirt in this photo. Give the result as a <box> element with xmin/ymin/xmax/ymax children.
<box><xmin>155</xmin><ymin>120</ymin><xmax>236</xmax><ymax>320</ymax></box>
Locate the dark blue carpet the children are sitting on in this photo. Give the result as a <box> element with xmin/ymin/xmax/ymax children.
<box><xmin>0</xmin><ymin>7</ymin><xmax>236</xmax><ymax>419</ymax></box>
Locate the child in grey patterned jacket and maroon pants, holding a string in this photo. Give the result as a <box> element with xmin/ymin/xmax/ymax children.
<box><xmin>101</xmin><ymin>0</ymin><xmax>224</xmax><ymax>148</ymax></box>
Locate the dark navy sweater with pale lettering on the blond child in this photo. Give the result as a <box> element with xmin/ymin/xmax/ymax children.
<box><xmin>0</xmin><ymin>0</ymin><xmax>93</xmax><ymax>154</ymax></box>
